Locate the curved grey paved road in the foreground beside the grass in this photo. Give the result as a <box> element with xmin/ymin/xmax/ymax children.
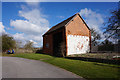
<box><xmin>2</xmin><ymin>57</ymin><xmax>84</xmax><ymax>78</ymax></box>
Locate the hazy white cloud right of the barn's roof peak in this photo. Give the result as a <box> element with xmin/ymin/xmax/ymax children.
<box><xmin>79</xmin><ymin>8</ymin><xmax>104</xmax><ymax>38</ymax></box>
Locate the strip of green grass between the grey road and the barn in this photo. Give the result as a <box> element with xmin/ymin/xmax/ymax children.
<box><xmin>4</xmin><ymin>53</ymin><xmax>120</xmax><ymax>79</ymax></box>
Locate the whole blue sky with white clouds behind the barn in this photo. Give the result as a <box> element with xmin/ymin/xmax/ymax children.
<box><xmin>0</xmin><ymin>2</ymin><xmax>118</xmax><ymax>47</ymax></box>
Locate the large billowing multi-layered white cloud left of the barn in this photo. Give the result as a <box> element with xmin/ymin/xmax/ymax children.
<box><xmin>10</xmin><ymin>5</ymin><xmax>49</xmax><ymax>46</ymax></box>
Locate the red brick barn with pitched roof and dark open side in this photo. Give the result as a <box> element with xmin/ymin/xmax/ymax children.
<box><xmin>43</xmin><ymin>13</ymin><xmax>91</xmax><ymax>56</ymax></box>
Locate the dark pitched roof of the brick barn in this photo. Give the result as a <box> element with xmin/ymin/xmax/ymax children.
<box><xmin>44</xmin><ymin>13</ymin><xmax>90</xmax><ymax>35</ymax></box>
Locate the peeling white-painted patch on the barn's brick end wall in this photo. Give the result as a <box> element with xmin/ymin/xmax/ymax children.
<box><xmin>67</xmin><ymin>35</ymin><xmax>90</xmax><ymax>55</ymax></box>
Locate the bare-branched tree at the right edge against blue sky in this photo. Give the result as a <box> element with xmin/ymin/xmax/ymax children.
<box><xmin>104</xmin><ymin>2</ymin><xmax>120</xmax><ymax>39</ymax></box>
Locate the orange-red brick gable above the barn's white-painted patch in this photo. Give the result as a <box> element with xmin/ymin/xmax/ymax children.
<box><xmin>66</xmin><ymin>15</ymin><xmax>89</xmax><ymax>36</ymax></box>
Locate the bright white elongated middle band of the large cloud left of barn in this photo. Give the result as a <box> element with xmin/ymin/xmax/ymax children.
<box><xmin>10</xmin><ymin>20</ymin><xmax>49</xmax><ymax>35</ymax></box>
